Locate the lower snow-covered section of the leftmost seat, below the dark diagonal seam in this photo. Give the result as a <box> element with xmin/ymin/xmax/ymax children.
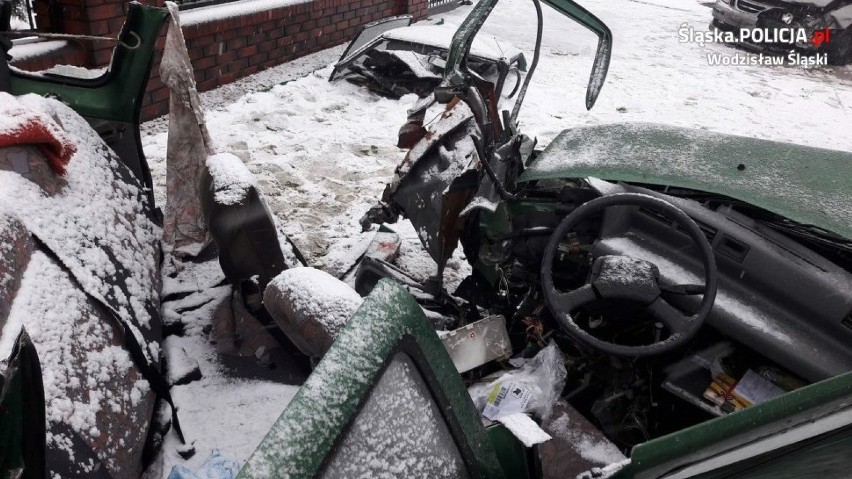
<box><xmin>16</xmin><ymin>253</ymin><xmax>155</xmax><ymax>478</ymax></box>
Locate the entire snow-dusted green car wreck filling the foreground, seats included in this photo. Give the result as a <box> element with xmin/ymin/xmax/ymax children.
<box><xmin>0</xmin><ymin>0</ymin><xmax>852</xmax><ymax>479</ymax></box>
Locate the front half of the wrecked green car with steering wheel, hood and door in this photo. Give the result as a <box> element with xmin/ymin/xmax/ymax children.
<box><xmin>250</xmin><ymin>0</ymin><xmax>852</xmax><ymax>478</ymax></box>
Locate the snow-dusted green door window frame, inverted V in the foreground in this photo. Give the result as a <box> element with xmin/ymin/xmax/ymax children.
<box><xmin>238</xmin><ymin>280</ymin><xmax>505</xmax><ymax>479</ymax></box>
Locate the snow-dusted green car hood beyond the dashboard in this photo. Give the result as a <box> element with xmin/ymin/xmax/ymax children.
<box><xmin>518</xmin><ymin>123</ymin><xmax>852</xmax><ymax>239</ymax></box>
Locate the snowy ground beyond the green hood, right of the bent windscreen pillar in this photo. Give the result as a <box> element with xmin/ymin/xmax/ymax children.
<box><xmin>484</xmin><ymin>0</ymin><xmax>852</xmax><ymax>151</ymax></box>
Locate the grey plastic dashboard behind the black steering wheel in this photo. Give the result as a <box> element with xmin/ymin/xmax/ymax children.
<box><xmin>591</xmin><ymin>180</ymin><xmax>852</xmax><ymax>382</ymax></box>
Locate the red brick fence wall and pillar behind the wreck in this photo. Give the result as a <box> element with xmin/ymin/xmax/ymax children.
<box><xmin>16</xmin><ymin>0</ymin><xmax>428</xmax><ymax>121</ymax></box>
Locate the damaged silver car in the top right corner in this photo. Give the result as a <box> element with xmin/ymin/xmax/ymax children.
<box><xmin>712</xmin><ymin>0</ymin><xmax>852</xmax><ymax>65</ymax></box>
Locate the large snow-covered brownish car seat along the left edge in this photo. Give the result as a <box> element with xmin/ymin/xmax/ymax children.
<box><xmin>0</xmin><ymin>96</ymin><xmax>160</xmax><ymax>477</ymax></box>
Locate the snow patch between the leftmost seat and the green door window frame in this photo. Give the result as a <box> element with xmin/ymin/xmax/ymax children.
<box><xmin>155</xmin><ymin>261</ymin><xmax>298</xmax><ymax>479</ymax></box>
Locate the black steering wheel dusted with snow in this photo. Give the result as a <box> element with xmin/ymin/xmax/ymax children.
<box><xmin>541</xmin><ymin>193</ymin><xmax>718</xmax><ymax>357</ymax></box>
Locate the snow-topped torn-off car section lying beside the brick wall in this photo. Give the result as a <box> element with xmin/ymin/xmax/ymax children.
<box><xmin>329</xmin><ymin>15</ymin><xmax>527</xmax><ymax>98</ymax></box>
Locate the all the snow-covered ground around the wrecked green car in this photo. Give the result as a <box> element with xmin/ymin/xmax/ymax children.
<box><xmin>143</xmin><ymin>0</ymin><xmax>852</xmax><ymax>474</ymax></box>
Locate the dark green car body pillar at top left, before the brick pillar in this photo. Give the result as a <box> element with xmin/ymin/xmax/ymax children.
<box><xmin>11</xmin><ymin>2</ymin><xmax>169</xmax><ymax>124</ymax></box>
